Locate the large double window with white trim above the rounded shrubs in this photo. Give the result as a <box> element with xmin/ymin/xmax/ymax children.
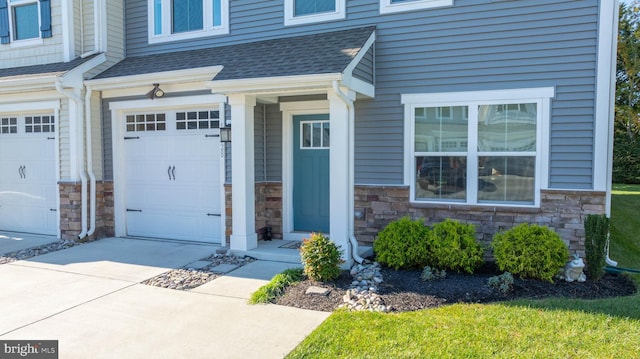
<box><xmin>402</xmin><ymin>88</ymin><xmax>554</xmax><ymax>206</ymax></box>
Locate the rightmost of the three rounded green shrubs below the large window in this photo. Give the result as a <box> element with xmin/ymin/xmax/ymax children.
<box><xmin>492</xmin><ymin>223</ymin><xmax>569</xmax><ymax>283</ymax></box>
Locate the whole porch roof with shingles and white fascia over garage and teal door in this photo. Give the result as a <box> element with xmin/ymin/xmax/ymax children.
<box><xmin>85</xmin><ymin>26</ymin><xmax>375</xmax><ymax>97</ymax></box>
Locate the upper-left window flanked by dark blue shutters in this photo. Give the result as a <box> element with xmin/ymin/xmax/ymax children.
<box><xmin>0</xmin><ymin>0</ymin><xmax>51</xmax><ymax>45</ymax></box>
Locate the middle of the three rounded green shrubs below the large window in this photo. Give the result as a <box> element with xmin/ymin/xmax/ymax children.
<box><xmin>427</xmin><ymin>219</ymin><xmax>484</xmax><ymax>273</ymax></box>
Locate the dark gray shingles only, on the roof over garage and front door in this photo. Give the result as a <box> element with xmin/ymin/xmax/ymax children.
<box><xmin>95</xmin><ymin>26</ymin><xmax>375</xmax><ymax>80</ymax></box>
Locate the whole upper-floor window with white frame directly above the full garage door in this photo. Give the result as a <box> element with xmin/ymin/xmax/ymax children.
<box><xmin>148</xmin><ymin>0</ymin><xmax>229</xmax><ymax>43</ymax></box>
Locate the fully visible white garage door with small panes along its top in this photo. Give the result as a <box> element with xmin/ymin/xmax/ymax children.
<box><xmin>124</xmin><ymin>110</ymin><xmax>221</xmax><ymax>242</ymax></box>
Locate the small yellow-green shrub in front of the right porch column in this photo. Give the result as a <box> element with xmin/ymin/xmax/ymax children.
<box><xmin>300</xmin><ymin>233</ymin><xmax>342</xmax><ymax>282</ymax></box>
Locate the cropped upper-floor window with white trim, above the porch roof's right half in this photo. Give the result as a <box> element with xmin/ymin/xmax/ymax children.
<box><xmin>284</xmin><ymin>0</ymin><xmax>346</xmax><ymax>26</ymax></box>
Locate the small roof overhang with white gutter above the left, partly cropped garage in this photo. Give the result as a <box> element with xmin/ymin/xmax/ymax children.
<box><xmin>0</xmin><ymin>53</ymin><xmax>106</xmax><ymax>94</ymax></box>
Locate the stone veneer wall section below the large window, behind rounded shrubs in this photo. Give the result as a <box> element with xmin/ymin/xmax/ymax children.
<box><xmin>355</xmin><ymin>186</ymin><xmax>606</xmax><ymax>257</ymax></box>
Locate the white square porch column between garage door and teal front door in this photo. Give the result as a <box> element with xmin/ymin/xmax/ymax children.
<box><xmin>229</xmin><ymin>95</ymin><xmax>258</xmax><ymax>251</ymax></box>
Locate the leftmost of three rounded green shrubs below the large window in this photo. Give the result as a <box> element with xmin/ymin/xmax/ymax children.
<box><xmin>373</xmin><ymin>217</ymin><xmax>429</xmax><ymax>270</ymax></box>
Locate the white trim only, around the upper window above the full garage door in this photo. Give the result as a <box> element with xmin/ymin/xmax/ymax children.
<box><xmin>147</xmin><ymin>0</ymin><xmax>229</xmax><ymax>44</ymax></box>
